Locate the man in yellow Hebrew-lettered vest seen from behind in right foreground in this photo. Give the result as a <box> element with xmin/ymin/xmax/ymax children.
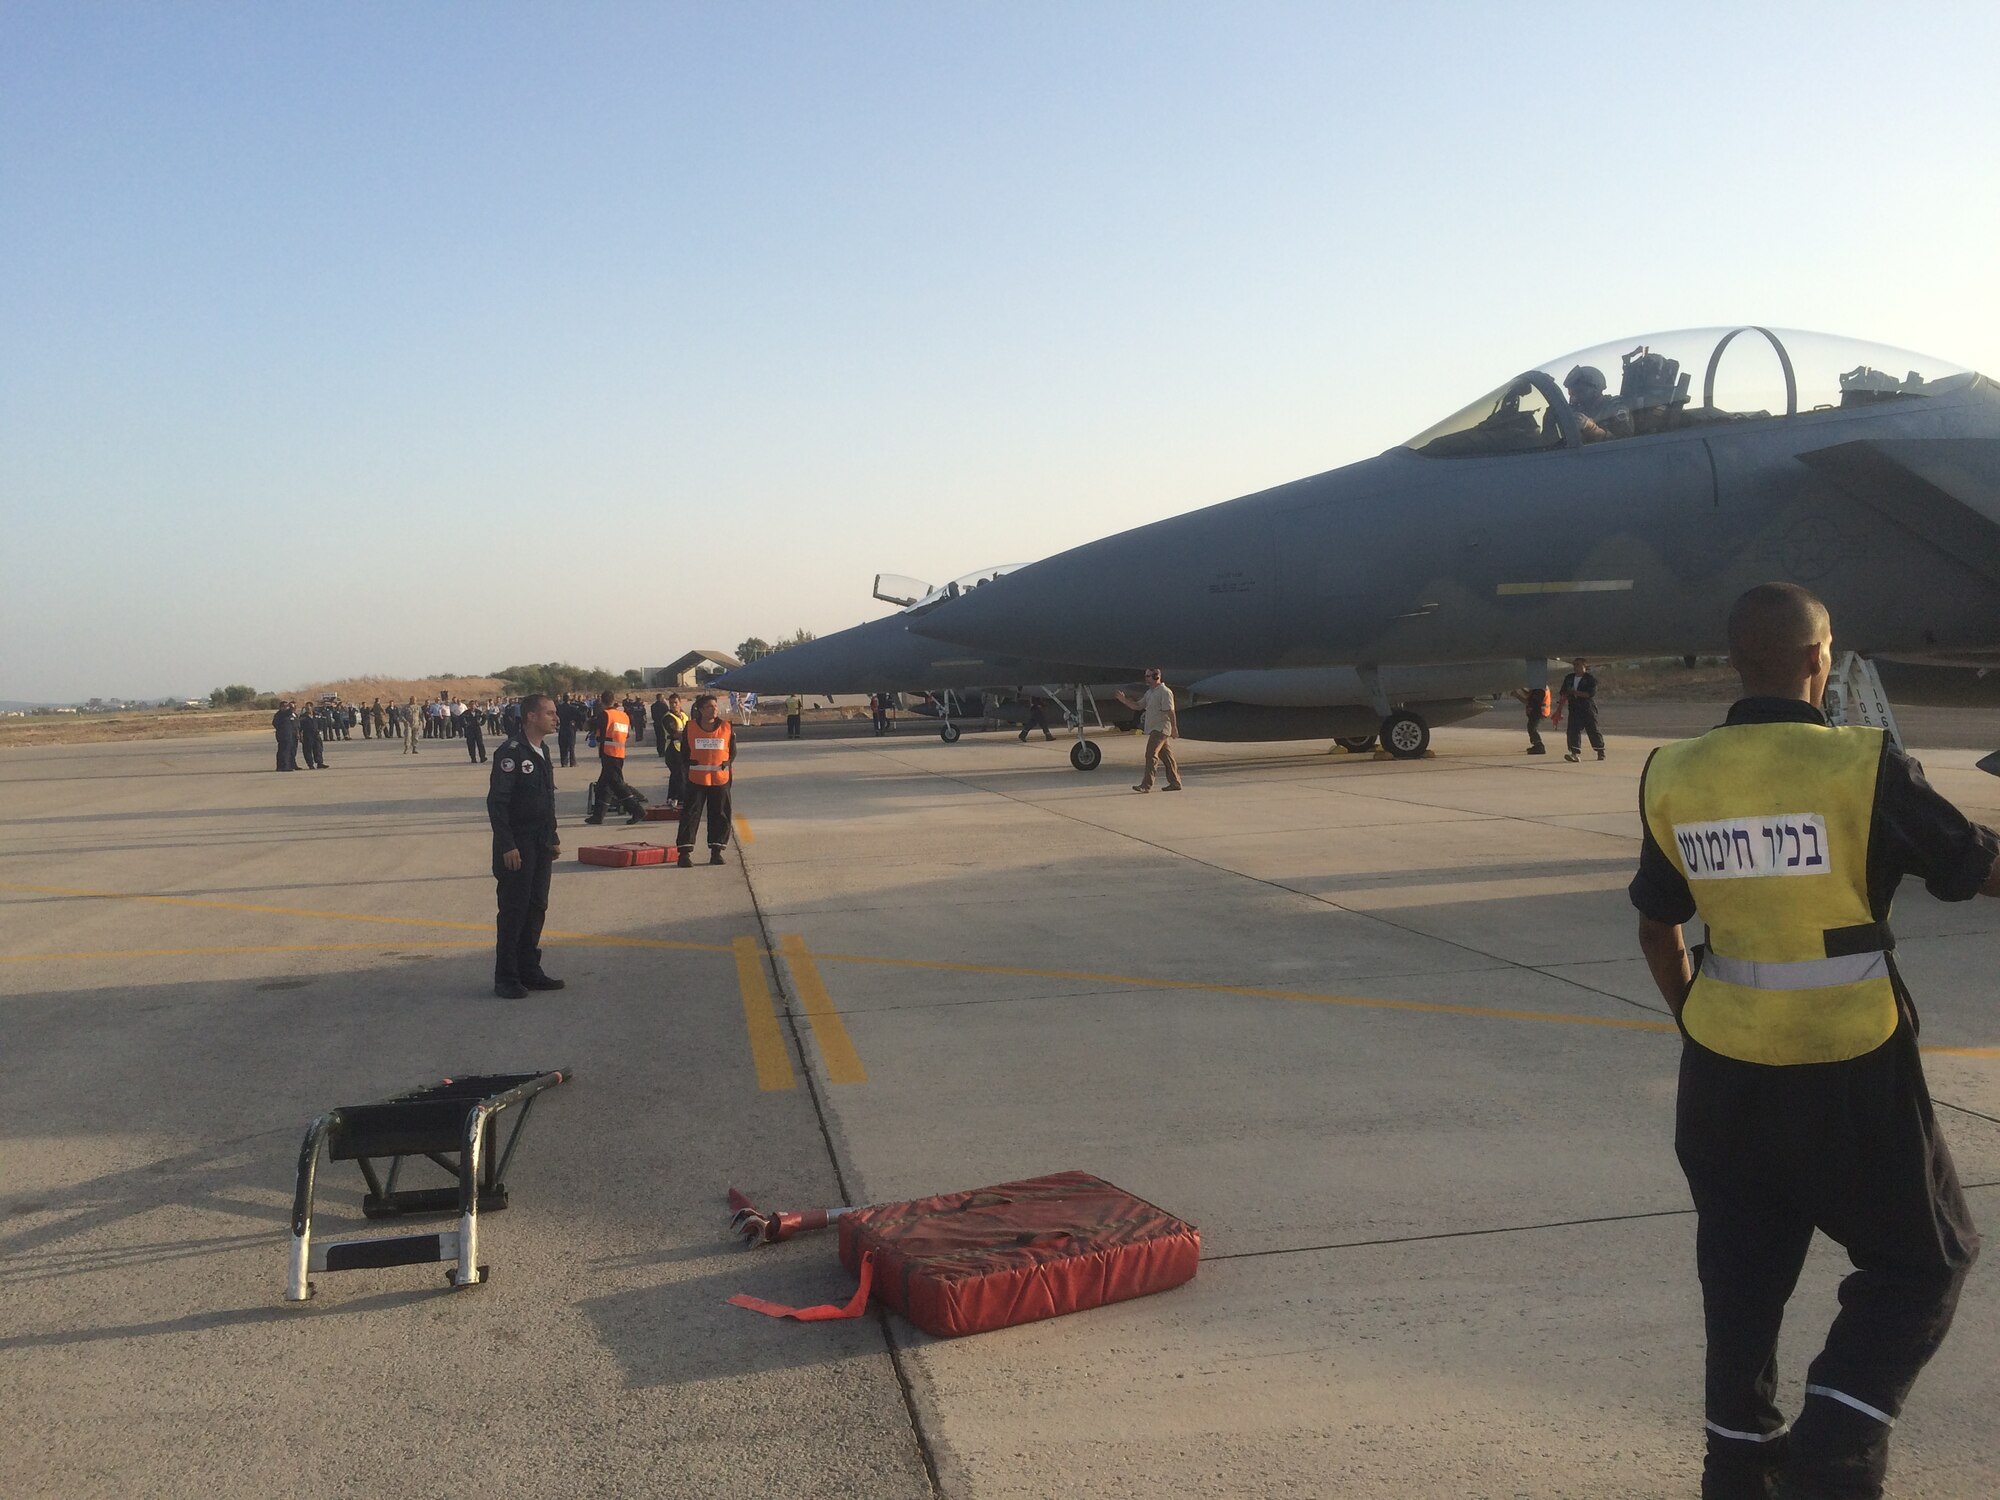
<box><xmin>1630</xmin><ymin>584</ymin><xmax>2000</xmax><ymax>1500</ymax></box>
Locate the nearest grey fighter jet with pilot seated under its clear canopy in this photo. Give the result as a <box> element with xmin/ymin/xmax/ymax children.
<box><xmin>912</xmin><ymin>326</ymin><xmax>2000</xmax><ymax>752</ymax></box>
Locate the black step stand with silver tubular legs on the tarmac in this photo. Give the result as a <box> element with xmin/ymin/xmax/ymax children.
<box><xmin>284</xmin><ymin>1068</ymin><xmax>576</xmax><ymax>1302</ymax></box>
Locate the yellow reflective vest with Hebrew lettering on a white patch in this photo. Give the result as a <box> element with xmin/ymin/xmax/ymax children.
<box><xmin>1642</xmin><ymin>724</ymin><xmax>1898</xmax><ymax>1064</ymax></box>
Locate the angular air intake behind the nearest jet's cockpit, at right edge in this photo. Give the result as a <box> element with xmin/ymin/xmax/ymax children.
<box><xmin>1798</xmin><ymin>438</ymin><xmax>2000</xmax><ymax>582</ymax></box>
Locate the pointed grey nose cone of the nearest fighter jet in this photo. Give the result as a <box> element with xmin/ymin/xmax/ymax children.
<box><xmin>912</xmin><ymin>506</ymin><xmax>1278</xmax><ymax>666</ymax></box>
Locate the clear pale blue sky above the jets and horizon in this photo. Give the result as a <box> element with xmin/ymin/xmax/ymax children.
<box><xmin>0</xmin><ymin>0</ymin><xmax>2000</xmax><ymax>698</ymax></box>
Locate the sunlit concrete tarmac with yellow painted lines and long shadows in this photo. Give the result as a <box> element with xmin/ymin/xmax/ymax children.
<box><xmin>0</xmin><ymin>720</ymin><xmax>2000</xmax><ymax>1500</ymax></box>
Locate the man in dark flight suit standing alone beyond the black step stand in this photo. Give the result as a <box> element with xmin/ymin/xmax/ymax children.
<box><xmin>486</xmin><ymin>692</ymin><xmax>562</xmax><ymax>1000</ymax></box>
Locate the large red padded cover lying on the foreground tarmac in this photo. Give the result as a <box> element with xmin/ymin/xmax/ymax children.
<box><xmin>838</xmin><ymin>1172</ymin><xmax>1202</xmax><ymax>1338</ymax></box>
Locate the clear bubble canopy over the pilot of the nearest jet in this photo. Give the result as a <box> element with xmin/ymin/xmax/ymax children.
<box><xmin>1404</xmin><ymin>326</ymin><xmax>1972</xmax><ymax>458</ymax></box>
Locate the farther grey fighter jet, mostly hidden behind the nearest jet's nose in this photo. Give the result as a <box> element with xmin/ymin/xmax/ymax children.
<box><xmin>710</xmin><ymin>568</ymin><xmax>1522</xmax><ymax>770</ymax></box>
